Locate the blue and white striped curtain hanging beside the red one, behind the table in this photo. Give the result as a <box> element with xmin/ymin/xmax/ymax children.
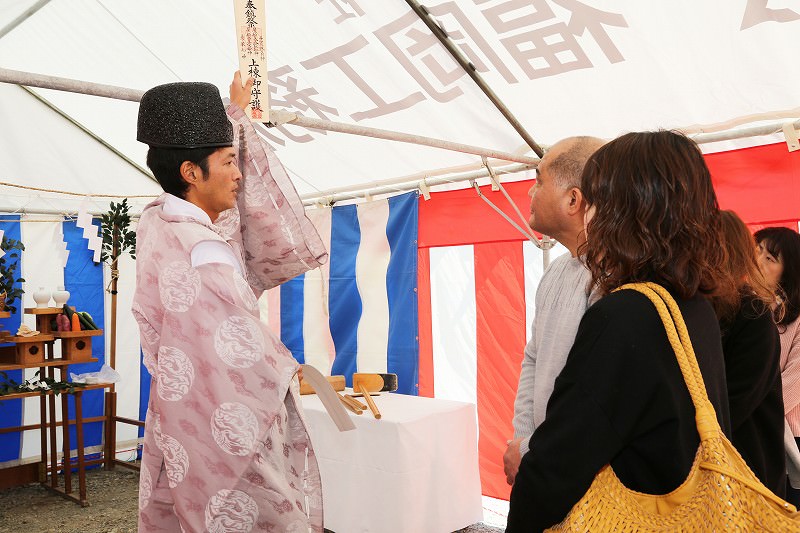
<box><xmin>269</xmin><ymin>192</ymin><xmax>419</xmax><ymax>394</ymax></box>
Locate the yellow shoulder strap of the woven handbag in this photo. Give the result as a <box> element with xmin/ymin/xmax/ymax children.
<box><xmin>615</xmin><ymin>282</ymin><xmax>722</xmax><ymax>442</ymax></box>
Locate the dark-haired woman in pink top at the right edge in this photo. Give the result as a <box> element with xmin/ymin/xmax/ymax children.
<box><xmin>755</xmin><ymin>223</ymin><xmax>800</xmax><ymax>506</ymax></box>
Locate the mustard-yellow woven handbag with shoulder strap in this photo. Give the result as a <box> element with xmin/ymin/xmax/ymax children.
<box><xmin>548</xmin><ymin>283</ymin><xmax>800</xmax><ymax>533</ymax></box>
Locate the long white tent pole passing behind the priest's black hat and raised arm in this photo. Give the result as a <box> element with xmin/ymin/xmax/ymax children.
<box><xmin>0</xmin><ymin>68</ymin><xmax>538</xmax><ymax>163</ymax></box>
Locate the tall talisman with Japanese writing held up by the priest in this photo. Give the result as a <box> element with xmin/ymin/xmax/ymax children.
<box><xmin>233</xmin><ymin>0</ymin><xmax>269</xmax><ymax>122</ymax></box>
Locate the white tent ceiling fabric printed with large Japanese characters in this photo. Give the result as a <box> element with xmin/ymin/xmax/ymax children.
<box><xmin>0</xmin><ymin>0</ymin><xmax>800</xmax><ymax>206</ymax></box>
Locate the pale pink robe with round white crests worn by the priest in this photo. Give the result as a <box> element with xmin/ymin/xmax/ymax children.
<box><xmin>133</xmin><ymin>106</ymin><xmax>327</xmax><ymax>533</ymax></box>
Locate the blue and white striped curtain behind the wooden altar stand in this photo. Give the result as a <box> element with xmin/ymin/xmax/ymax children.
<box><xmin>0</xmin><ymin>215</ymin><xmax>140</xmax><ymax>466</ymax></box>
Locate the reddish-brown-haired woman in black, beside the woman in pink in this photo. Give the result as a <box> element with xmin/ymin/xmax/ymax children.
<box><xmin>713</xmin><ymin>211</ymin><xmax>786</xmax><ymax>497</ymax></box>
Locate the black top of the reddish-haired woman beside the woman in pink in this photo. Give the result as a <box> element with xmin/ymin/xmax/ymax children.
<box><xmin>722</xmin><ymin>296</ymin><xmax>786</xmax><ymax>497</ymax></box>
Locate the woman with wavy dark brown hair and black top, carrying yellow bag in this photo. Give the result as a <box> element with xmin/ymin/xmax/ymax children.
<box><xmin>506</xmin><ymin>131</ymin><xmax>731</xmax><ymax>533</ymax></box>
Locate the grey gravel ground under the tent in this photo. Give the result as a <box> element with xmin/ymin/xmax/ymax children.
<box><xmin>0</xmin><ymin>467</ymin><xmax>502</xmax><ymax>533</ymax></box>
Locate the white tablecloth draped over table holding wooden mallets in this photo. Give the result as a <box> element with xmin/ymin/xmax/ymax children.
<box><xmin>303</xmin><ymin>393</ymin><xmax>483</xmax><ymax>533</ymax></box>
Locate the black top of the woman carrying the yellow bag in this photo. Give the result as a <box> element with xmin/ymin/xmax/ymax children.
<box><xmin>506</xmin><ymin>290</ymin><xmax>730</xmax><ymax>533</ymax></box>
